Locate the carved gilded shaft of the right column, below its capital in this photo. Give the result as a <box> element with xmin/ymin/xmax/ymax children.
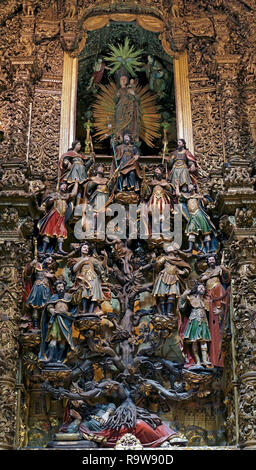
<box><xmin>227</xmin><ymin>241</ymin><xmax>256</xmax><ymax>450</ymax></box>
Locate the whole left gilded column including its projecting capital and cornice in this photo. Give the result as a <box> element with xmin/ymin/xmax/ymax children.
<box><xmin>0</xmin><ymin>160</ymin><xmax>37</xmax><ymax>450</ymax></box>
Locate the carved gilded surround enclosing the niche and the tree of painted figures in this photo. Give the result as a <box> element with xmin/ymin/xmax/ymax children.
<box><xmin>0</xmin><ymin>0</ymin><xmax>256</xmax><ymax>450</ymax></box>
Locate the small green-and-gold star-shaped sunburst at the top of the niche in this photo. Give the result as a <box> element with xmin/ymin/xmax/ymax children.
<box><xmin>104</xmin><ymin>38</ymin><xmax>143</xmax><ymax>77</ymax></box>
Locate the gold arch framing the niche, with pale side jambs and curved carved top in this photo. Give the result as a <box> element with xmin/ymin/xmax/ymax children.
<box><xmin>59</xmin><ymin>13</ymin><xmax>194</xmax><ymax>155</ymax></box>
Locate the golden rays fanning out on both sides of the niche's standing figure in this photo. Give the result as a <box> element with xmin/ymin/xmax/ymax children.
<box><xmin>92</xmin><ymin>81</ymin><xmax>161</xmax><ymax>147</ymax></box>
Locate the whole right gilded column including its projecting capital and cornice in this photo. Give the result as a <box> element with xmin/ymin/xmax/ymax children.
<box><xmin>217</xmin><ymin>106</ymin><xmax>256</xmax><ymax>449</ymax></box>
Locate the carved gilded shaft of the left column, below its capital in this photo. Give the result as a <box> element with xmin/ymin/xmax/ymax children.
<box><xmin>0</xmin><ymin>237</ymin><xmax>32</xmax><ymax>450</ymax></box>
